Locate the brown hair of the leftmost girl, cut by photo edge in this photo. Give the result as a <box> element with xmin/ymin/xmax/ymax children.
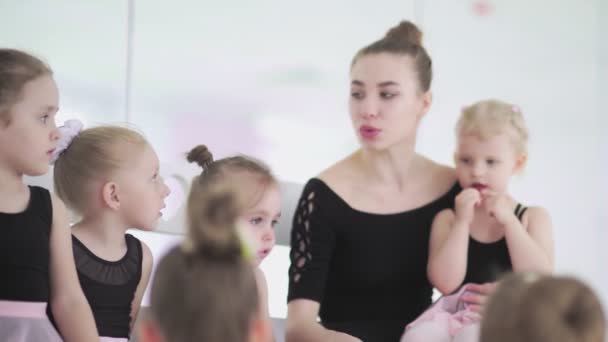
<box><xmin>0</xmin><ymin>49</ymin><xmax>53</xmax><ymax>124</ymax></box>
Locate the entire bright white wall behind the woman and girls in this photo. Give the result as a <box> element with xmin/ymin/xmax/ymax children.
<box><xmin>0</xmin><ymin>0</ymin><xmax>608</xmax><ymax>312</ymax></box>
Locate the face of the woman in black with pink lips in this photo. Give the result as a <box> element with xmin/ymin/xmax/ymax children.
<box><xmin>349</xmin><ymin>53</ymin><xmax>431</xmax><ymax>150</ymax></box>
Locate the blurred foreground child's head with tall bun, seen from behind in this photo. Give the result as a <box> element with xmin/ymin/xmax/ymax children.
<box><xmin>150</xmin><ymin>177</ymin><xmax>260</xmax><ymax>342</ymax></box>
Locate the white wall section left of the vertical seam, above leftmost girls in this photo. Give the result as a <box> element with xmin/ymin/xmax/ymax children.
<box><xmin>0</xmin><ymin>0</ymin><xmax>127</xmax><ymax>123</ymax></box>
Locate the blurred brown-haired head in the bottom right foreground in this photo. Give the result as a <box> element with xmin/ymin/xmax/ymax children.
<box><xmin>480</xmin><ymin>276</ymin><xmax>606</xmax><ymax>342</ymax></box>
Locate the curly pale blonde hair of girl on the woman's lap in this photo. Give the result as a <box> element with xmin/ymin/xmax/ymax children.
<box><xmin>456</xmin><ymin>99</ymin><xmax>528</xmax><ymax>156</ymax></box>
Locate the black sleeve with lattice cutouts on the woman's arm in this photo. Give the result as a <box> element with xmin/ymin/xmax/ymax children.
<box><xmin>287</xmin><ymin>182</ymin><xmax>335</xmax><ymax>302</ymax></box>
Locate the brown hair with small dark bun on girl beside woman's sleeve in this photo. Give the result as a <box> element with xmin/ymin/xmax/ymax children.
<box><xmin>186</xmin><ymin>145</ymin><xmax>277</xmax><ymax>207</ymax></box>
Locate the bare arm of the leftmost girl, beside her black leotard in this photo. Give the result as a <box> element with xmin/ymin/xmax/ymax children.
<box><xmin>49</xmin><ymin>195</ymin><xmax>99</xmax><ymax>342</ymax></box>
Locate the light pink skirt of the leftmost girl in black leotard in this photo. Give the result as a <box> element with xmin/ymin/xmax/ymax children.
<box><xmin>0</xmin><ymin>300</ymin><xmax>62</xmax><ymax>342</ymax></box>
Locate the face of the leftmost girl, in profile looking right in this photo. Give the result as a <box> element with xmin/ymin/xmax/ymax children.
<box><xmin>0</xmin><ymin>75</ymin><xmax>60</xmax><ymax>176</ymax></box>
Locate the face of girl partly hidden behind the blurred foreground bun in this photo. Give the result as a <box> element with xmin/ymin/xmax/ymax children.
<box><xmin>239</xmin><ymin>184</ymin><xmax>281</xmax><ymax>265</ymax></box>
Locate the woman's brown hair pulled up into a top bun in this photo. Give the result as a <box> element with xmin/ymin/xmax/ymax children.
<box><xmin>351</xmin><ymin>20</ymin><xmax>433</xmax><ymax>92</ymax></box>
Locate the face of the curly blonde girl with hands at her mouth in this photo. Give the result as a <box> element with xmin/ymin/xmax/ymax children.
<box><xmin>454</xmin><ymin>133</ymin><xmax>525</xmax><ymax>194</ymax></box>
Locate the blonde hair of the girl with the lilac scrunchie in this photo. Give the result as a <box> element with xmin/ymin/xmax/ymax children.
<box><xmin>53</xmin><ymin>126</ymin><xmax>148</xmax><ymax>214</ymax></box>
